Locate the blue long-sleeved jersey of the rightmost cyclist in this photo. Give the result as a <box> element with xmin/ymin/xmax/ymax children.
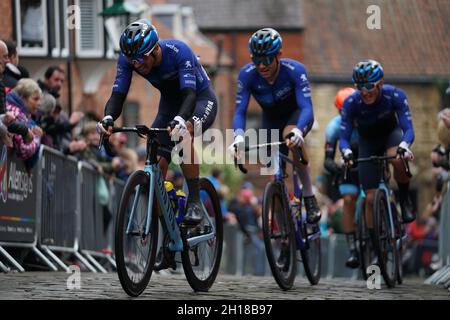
<box><xmin>339</xmin><ymin>84</ymin><xmax>414</xmax><ymax>151</ymax></box>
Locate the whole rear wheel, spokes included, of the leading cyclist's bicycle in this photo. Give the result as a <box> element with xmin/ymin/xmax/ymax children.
<box><xmin>181</xmin><ymin>178</ymin><xmax>223</xmax><ymax>291</ymax></box>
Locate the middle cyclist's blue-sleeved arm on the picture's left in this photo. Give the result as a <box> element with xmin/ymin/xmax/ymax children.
<box><xmin>233</xmin><ymin>67</ymin><xmax>250</xmax><ymax>136</ymax></box>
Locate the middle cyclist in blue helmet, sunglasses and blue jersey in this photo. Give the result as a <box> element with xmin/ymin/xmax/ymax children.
<box><xmin>229</xmin><ymin>28</ymin><xmax>321</xmax><ymax>223</ymax></box>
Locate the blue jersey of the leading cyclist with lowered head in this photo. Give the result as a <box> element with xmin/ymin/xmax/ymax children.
<box><xmin>113</xmin><ymin>40</ymin><xmax>210</xmax><ymax>100</ymax></box>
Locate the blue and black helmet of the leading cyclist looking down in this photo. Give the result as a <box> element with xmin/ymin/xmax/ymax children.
<box><xmin>120</xmin><ymin>19</ymin><xmax>159</xmax><ymax>58</ymax></box>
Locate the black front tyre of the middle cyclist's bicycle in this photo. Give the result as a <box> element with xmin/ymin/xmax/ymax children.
<box><xmin>262</xmin><ymin>181</ymin><xmax>297</xmax><ymax>290</ymax></box>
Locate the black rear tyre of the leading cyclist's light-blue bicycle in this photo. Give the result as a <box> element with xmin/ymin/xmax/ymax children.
<box><xmin>181</xmin><ymin>178</ymin><xmax>223</xmax><ymax>292</ymax></box>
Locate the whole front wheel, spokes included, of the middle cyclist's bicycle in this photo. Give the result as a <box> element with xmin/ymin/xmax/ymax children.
<box><xmin>262</xmin><ymin>182</ymin><xmax>297</xmax><ymax>290</ymax></box>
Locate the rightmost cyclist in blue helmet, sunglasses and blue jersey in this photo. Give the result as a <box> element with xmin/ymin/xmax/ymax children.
<box><xmin>339</xmin><ymin>60</ymin><xmax>415</xmax><ymax>231</ymax></box>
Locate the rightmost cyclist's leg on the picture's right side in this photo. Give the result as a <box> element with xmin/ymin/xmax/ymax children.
<box><xmin>386</xmin><ymin>128</ymin><xmax>415</xmax><ymax>223</ymax></box>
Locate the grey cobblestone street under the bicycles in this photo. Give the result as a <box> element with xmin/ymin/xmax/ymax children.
<box><xmin>0</xmin><ymin>272</ymin><xmax>450</xmax><ymax>300</ymax></box>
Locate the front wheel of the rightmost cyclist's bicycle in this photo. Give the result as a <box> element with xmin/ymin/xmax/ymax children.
<box><xmin>373</xmin><ymin>189</ymin><xmax>398</xmax><ymax>288</ymax></box>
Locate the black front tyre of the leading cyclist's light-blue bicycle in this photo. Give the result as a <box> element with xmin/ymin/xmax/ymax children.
<box><xmin>115</xmin><ymin>170</ymin><xmax>158</xmax><ymax>297</ymax></box>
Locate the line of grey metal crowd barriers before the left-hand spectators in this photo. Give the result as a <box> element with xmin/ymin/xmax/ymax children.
<box><xmin>0</xmin><ymin>145</ymin><xmax>124</xmax><ymax>272</ymax></box>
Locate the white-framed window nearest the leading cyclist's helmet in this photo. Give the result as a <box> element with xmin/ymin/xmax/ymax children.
<box><xmin>75</xmin><ymin>0</ymin><xmax>104</xmax><ymax>58</ymax></box>
